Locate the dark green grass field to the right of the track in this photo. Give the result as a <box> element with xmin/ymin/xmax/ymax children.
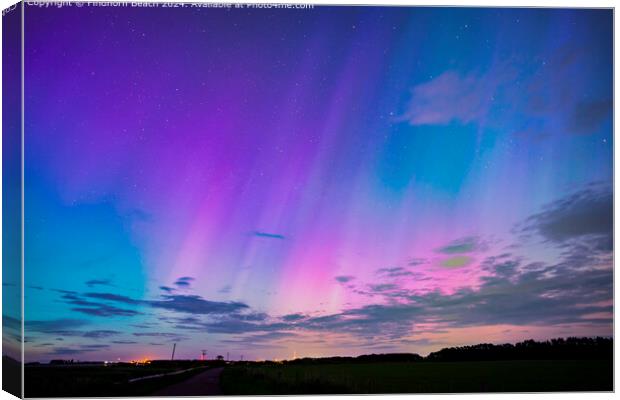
<box><xmin>221</xmin><ymin>360</ymin><xmax>613</xmax><ymax>395</ymax></box>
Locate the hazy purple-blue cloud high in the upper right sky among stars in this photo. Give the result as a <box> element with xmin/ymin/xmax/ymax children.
<box><xmin>401</xmin><ymin>43</ymin><xmax>613</xmax><ymax>138</ymax></box>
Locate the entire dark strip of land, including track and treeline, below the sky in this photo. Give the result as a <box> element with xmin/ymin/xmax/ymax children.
<box><xmin>24</xmin><ymin>337</ymin><xmax>613</xmax><ymax>397</ymax></box>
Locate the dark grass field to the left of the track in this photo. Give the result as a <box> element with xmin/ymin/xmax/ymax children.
<box><xmin>24</xmin><ymin>365</ymin><xmax>209</xmax><ymax>397</ymax></box>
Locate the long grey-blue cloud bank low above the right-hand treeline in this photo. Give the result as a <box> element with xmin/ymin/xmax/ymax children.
<box><xmin>296</xmin><ymin>260</ymin><xmax>612</xmax><ymax>338</ymax></box>
